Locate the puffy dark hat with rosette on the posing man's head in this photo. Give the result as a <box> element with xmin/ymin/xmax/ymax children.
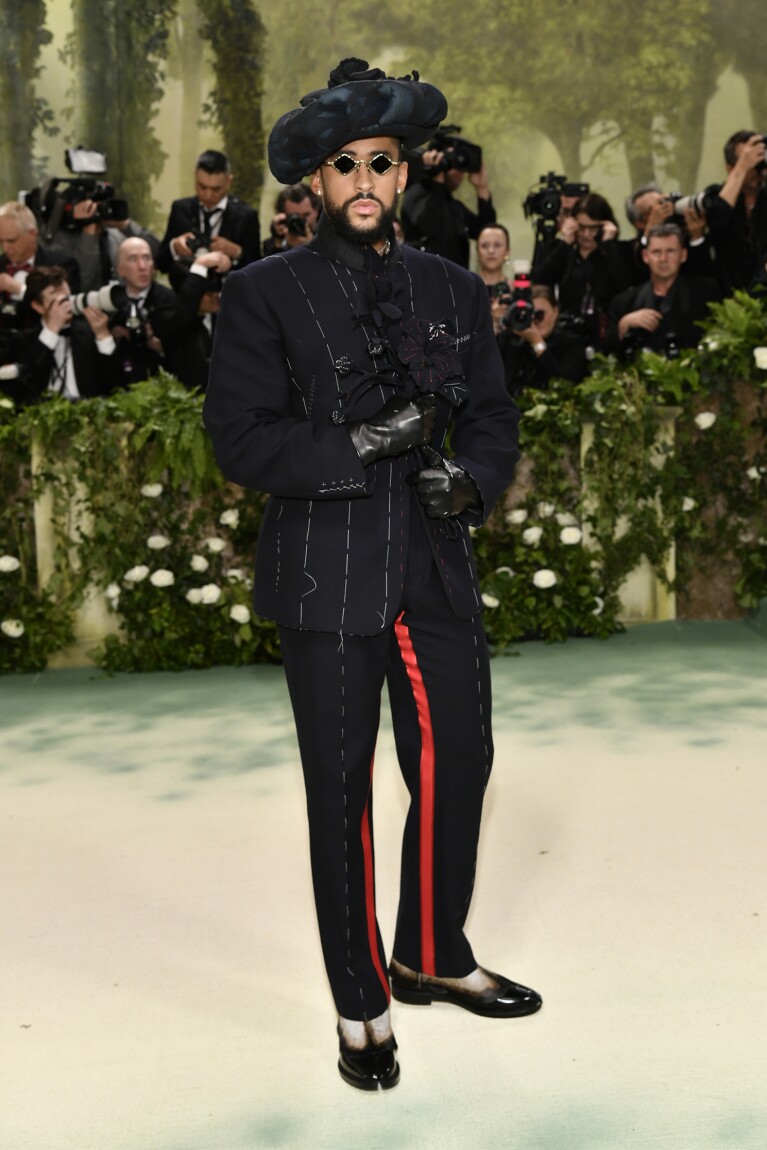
<box><xmin>269</xmin><ymin>59</ymin><xmax>447</xmax><ymax>184</ymax></box>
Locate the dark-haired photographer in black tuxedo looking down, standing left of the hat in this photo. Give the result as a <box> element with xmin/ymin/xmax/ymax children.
<box><xmin>158</xmin><ymin>151</ymin><xmax>261</xmax><ymax>291</ymax></box>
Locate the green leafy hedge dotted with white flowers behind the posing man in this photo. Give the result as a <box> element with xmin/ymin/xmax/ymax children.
<box><xmin>0</xmin><ymin>293</ymin><xmax>767</xmax><ymax>672</ymax></box>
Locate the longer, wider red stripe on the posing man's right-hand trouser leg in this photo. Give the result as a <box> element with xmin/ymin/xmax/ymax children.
<box><xmin>394</xmin><ymin>613</ymin><xmax>437</xmax><ymax>974</ymax></box>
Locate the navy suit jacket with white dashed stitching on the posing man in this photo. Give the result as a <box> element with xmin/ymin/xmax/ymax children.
<box><xmin>204</xmin><ymin>219</ymin><xmax>519</xmax><ymax>635</ymax></box>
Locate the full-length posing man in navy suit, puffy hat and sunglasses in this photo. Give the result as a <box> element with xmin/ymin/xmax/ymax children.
<box><xmin>205</xmin><ymin>60</ymin><xmax>540</xmax><ymax>1090</ymax></box>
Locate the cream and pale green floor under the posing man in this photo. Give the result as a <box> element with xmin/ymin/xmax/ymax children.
<box><xmin>0</xmin><ymin>624</ymin><xmax>767</xmax><ymax>1150</ymax></box>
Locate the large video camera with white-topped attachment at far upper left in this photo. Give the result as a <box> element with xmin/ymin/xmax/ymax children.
<box><xmin>24</xmin><ymin>145</ymin><xmax>130</xmax><ymax>243</ymax></box>
